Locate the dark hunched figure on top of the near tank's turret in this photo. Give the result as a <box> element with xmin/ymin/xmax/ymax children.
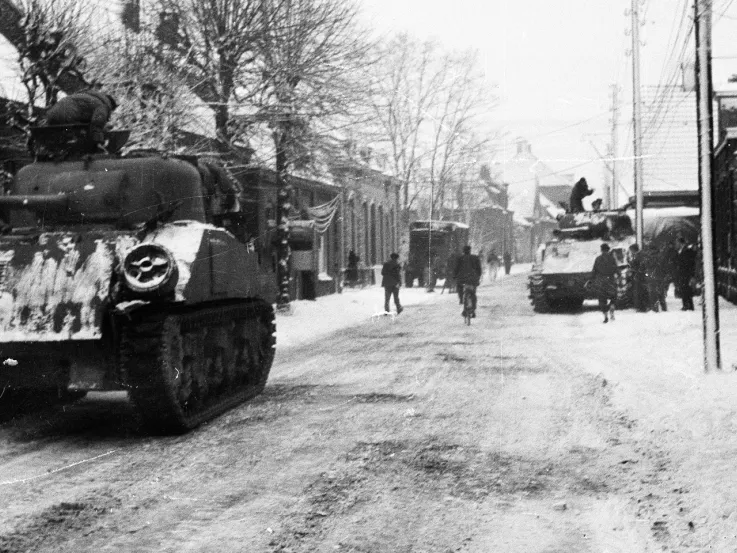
<box><xmin>44</xmin><ymin>89</ymin><xmax>118</xmax><ymax>152</ymax></box>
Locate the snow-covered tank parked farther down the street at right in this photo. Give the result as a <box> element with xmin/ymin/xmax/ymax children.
<box><xmin>528</xmin><ymin>211</ymin><xmax>635</xmax><ymax>313</ymax></box>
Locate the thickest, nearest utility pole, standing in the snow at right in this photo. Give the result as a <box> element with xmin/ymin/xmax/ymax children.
<box><xmin>694</xmin><ymin>0</ymin><xmax>721</xmax><ymax>372</ymax></box>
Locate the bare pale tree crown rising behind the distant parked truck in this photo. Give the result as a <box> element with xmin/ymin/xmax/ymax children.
<box><xmin>372</xmin><ymin>35</ymin><xmax>494</xmax><ymax>222</ymax></box>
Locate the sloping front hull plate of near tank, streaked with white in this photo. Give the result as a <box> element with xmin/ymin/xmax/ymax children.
<box><xmin>0</xmin><ymin>231</ymin><xmax>135</xmax><ymax>342</ymax></box>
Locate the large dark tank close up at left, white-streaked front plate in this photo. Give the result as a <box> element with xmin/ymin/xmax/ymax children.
<box><xmin>0</xmin><ymin>126</ymin><xmax>276</xmax><ymax>433</ymax></box>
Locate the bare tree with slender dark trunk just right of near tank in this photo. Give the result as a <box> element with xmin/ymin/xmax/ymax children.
<box><xmin>255</xmin><ymin>0</ymin><xmax>369</xmax><ymax>309</ymax></box>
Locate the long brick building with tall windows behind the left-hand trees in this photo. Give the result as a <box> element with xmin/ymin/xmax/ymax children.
<box><xmin>234</xmin><ymin>157</ymin><xmax>399</xmax><ymax>299</ymax></box>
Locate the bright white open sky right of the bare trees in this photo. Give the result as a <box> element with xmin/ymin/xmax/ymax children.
<box><xmin>359</xmin><ymin>0</ymin><xmax>737</xmax><ymax>195</ymax></box>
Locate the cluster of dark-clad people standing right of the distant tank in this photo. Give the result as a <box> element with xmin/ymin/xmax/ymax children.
<box><xmin>629</xmin><ymin>236</ymin><xmax>697</xmax><ymax>312</ymax></box>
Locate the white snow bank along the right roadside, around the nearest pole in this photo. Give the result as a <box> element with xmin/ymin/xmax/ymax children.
<box><xmin>548</xmin><ymin>288</ymin><xmax>737</xmax><ymax>553</ymax></box>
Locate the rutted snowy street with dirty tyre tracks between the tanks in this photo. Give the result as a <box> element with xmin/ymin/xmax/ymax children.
<box><xmin>0</xmin><ymin>275</ymin><xmax>720</xmax><ymax>553</ymax></box>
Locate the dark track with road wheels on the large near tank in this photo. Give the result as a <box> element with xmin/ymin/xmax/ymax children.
<box><xmin>120</xmin><ymin>300</ymin><xmax>276</xmax><ymax>433</ymax></box>
